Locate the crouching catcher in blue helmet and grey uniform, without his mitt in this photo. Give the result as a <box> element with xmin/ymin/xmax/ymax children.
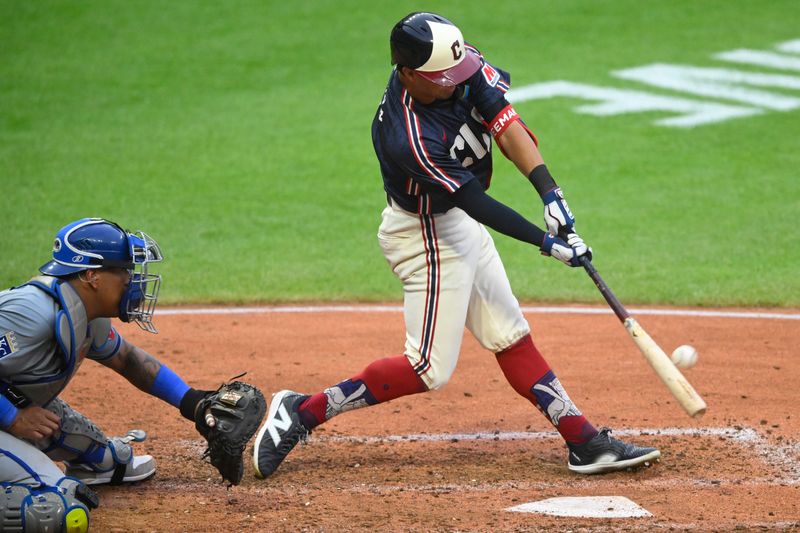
<box><xmin>0</xmin><ymin>218</ymin><xmax>256</xmax><ymax>532</ymax></box>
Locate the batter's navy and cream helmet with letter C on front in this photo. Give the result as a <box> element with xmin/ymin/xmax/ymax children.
<box><xmin>389</xmin><ymin>13</ymin><xmax>481</xmax><ymax>86</ymax></box>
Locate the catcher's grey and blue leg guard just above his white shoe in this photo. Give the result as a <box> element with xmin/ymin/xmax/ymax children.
<box><xmin>34</xmin><ymin>398</ymin><xmax>108</xmax><ymax>462</ymax></box>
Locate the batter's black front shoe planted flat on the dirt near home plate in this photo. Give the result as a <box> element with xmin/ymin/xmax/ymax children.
<box><xmin>567</xmin><ymin>428</ymin><xmax>661</xmax><ymax>474</ymax></box>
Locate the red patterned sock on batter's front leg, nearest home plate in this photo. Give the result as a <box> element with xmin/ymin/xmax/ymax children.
<box><xmin>496</xmin><ymin>335</ymin><xmax>597</xmax><ymax>444</ymax></box>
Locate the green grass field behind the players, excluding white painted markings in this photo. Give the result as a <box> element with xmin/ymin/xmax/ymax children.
<box><xmin>0</xmin><ymin>0</ymin><xmax>800</xmax><ymax>306</ymax></box>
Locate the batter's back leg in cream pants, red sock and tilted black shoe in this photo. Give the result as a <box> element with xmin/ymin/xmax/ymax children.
<box><xmin>253</xmin><ymin>207</ymin><xmax>481</xmax><ymax>477</ymax></box>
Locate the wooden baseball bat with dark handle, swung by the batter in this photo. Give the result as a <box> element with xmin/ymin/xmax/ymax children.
<box><xmin>581</xmin><ymin>256</ymin><xmax>706</xmax><ymax>417</ymax></box>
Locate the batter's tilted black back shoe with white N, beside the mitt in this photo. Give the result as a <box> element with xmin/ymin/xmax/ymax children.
<box><xmin>253</xmin><ymin>390</ymin><xmax>311</xmax><ymax>479</ymax></box>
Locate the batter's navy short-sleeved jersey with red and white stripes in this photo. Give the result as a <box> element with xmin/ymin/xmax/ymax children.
<box><xmin>372</xmin><ymin>48</ymin><xmax>514</xmax><ymax>214</ymax></box>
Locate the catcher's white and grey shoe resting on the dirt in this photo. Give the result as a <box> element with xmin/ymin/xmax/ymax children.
<box><xmin>64</xmin><ymin>429</ymin><xmax>156</xmax><ymax>485</ymax></box>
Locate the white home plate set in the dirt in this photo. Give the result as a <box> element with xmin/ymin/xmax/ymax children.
<box><xmin>506</xmin><ymin>496</ymin><xmax>653</xmax><ymax>518</ymax></box>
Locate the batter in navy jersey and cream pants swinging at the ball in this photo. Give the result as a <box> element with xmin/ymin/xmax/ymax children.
<box><xmin>254</xmin><ymin>13</ymin><xmax>660</xmax><ymax>477</ymax></box>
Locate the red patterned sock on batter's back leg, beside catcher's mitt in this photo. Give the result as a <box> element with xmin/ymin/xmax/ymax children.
<box><xmin>299</xmin><ymin>355</ymin><xmax>428</xmax><ymax>429</ymax></box>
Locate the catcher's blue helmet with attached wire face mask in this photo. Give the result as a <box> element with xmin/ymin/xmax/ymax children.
<box><xmin>39</xmin><ymin>218</ymin><xmax>163</xmax><ymax>333</ymax></box>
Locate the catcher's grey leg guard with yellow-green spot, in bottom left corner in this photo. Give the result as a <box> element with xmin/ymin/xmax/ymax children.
<box><xmin>0</xmin><ymin>478</ymin><xmax>99</xmax><ymax>533</ymax></box>
